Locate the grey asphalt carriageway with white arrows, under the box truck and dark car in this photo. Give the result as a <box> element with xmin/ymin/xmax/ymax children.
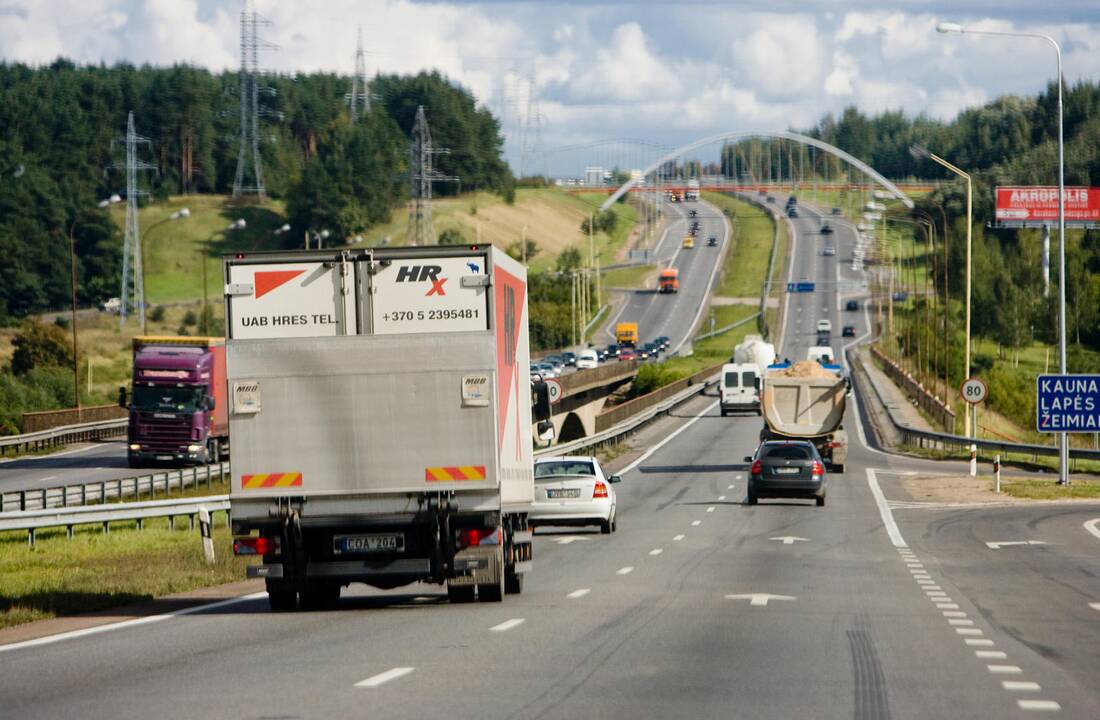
<box><xmin>0</xmin><ymin>194</ymin><xmax>1100</xmax><ymax>720</ymax></box>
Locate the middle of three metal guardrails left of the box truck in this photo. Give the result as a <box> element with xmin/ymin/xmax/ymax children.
<box><xmin>0</xmin><ymin>463</ymin><xmax>229</xmax><ymax>518</ymax></box>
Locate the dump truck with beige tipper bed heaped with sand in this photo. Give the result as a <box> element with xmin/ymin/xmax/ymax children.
<box><xmin>760</xmin><ymin>361</ymin><xmax>850</xmax><ymax>473</ymax></box>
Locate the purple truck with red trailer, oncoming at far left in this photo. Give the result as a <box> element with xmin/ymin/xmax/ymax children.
<box><xmin>119</xmin><ymin>336</ymin><xmax>229</xmax><ymax>467</ymax></box>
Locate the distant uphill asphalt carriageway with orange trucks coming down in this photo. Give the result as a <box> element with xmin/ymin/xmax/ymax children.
<box><xmin>604</xmin><ymin>200</ymin><xmax>729</xmax><ymax>352</ymax></box>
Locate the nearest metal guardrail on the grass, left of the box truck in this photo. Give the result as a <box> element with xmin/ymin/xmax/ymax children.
<box><xmin>0</xmin><ymin>495</ymin><xmax>229</xmax><ymax>547</ymax></box>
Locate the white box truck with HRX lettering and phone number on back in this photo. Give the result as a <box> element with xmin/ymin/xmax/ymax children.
<box><xmin>224</xmin><ymin>246</ymin><xmax>535</xmax><ymax>610</ymax></box>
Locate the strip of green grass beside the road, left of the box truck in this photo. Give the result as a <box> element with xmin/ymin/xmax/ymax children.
<box><xmin>0</xmin><ymin>513</ymin><xmax>248</xmax><ymax>628</ymax></box>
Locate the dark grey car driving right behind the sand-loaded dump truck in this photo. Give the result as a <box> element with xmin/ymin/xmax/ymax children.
<box><xmin>745</xmin><ymin>441</ymin><xmax>825</xmax><ymax>507</ymax></box>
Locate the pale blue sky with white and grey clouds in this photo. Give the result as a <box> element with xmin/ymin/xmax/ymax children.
<box><xmin>0</xmin><ymin>0</ymin><xmax>1100</xmax><ymax>171</ymax></box>
